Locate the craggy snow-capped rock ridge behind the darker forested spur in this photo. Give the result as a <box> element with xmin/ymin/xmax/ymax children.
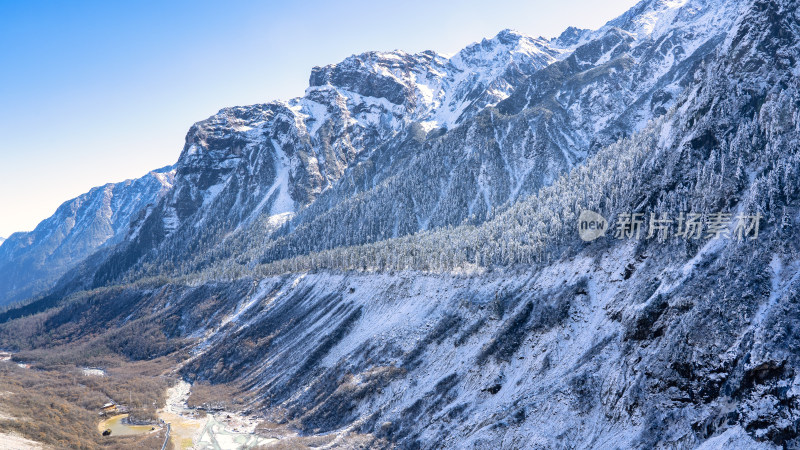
<box><xmin>89</xmin><ymin>31</ymin><xmax>558</xmax><ymax>280</ymax></box>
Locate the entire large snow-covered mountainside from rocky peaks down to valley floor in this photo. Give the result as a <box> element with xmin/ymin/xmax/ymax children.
<box><xmin>0</xmin><ymin>0</ymin><xmax>800</xmax><ymax>449</ymax></box>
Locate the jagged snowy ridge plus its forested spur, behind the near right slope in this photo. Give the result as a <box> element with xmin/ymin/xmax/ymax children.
<box><xmin>81</xmin><ymin>1</ymin><xmax>736</xmax><ymax>285</ymax></box>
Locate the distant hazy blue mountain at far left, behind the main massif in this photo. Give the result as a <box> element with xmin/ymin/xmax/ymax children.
<box><xmin>0</xmin><ymin>167</ymin><xmax>175</xmax><ymax>306</ymax></box>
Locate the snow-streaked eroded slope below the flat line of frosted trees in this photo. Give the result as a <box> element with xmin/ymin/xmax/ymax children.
<box><xmin>175</xmin><ymin>229</ymin><xmax>800</xmax><ymax>449</ymax></box>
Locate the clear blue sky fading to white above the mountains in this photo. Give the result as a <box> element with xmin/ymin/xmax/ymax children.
<box><xmin>0</xmin><ymin>0</ymin><xmax>636</xmax><ymax>237</ymax></box>
